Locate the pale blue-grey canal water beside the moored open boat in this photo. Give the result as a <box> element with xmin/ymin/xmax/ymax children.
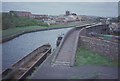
<box><xmin>2</xmin><ymin>28</ymin><xmax>71</xmax><ymax>70</ymax></box>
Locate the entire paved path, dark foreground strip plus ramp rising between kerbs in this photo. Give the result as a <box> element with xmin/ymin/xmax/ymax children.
<box><xmin>31</xmin><ymin>27</ymin><xmax>118</xmax><ymax>79</ymax></box>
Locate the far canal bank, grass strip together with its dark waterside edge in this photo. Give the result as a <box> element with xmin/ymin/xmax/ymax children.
<box><xmin>0</xmin><ymin>21</ymin><xmax>97</xmax><ymax>43</ymax></box>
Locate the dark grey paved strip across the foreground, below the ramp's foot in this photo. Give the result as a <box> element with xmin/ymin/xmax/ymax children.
<box><xmin>32</xmin><ymin>65</ymin><xmax>118</xmax><ymax>79</ymax></box>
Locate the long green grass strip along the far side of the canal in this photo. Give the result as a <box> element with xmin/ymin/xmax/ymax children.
<box><xmin>0</xmin><ymin>21</ymin><xmax>93</xmax><ymax>39</ymax></box>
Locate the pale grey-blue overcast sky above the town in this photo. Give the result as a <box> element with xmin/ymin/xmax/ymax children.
<box><xmin>2</xmin><ymin>2</ymin><xmax>118</xmax><ymax>17</ymax></box>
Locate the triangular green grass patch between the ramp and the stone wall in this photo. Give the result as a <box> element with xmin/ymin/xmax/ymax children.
<box><xmin>75</xmin><ymin>47</ymin><xmax>118</xmax><ymax>66</ymax></box>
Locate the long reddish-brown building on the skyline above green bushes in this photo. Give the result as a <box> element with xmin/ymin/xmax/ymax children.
<box><xmin>10</xmin><ymin>11</ymin><xmax>32</xmax><ymax>17</ymax></box>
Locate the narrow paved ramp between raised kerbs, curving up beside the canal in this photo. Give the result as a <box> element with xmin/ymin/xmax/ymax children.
<box><xmin>54</xmin><ymin>30</ymin><xmax>79</xmax><ymax>65</ymax></box>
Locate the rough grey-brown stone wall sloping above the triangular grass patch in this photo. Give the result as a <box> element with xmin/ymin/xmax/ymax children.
<box><xmin>80</xmin><ymin>36</ymin><xmax>118</xmax><ymax>60</ymax></box>
